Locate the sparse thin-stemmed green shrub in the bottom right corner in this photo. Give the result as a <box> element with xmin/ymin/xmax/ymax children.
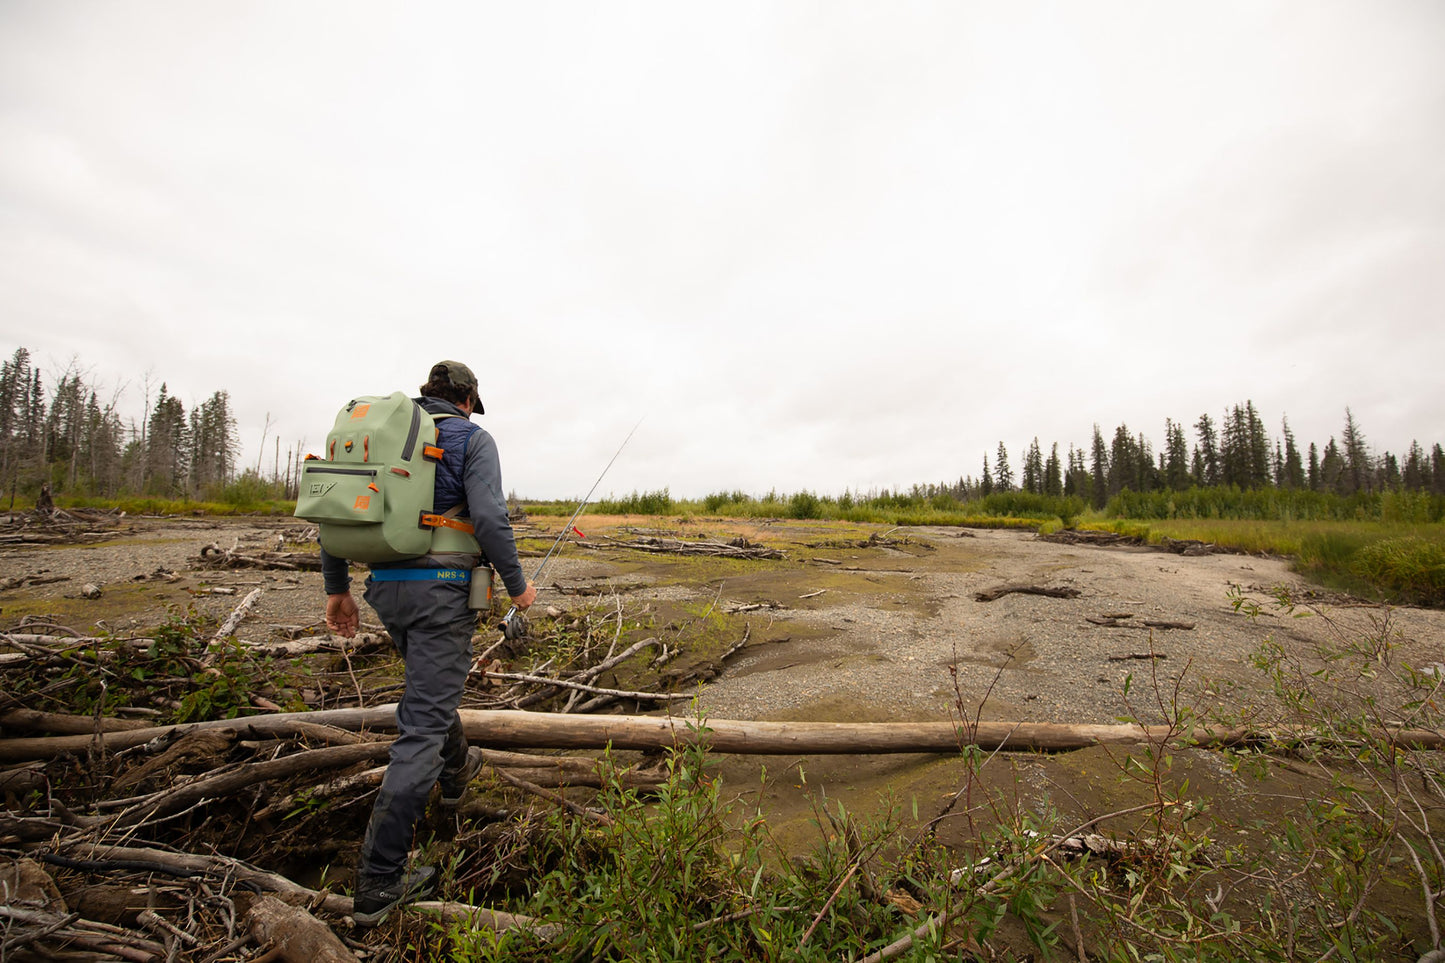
<box><xmin>1225</xmin><ymin>590</ymin><xmax>1445</xmax><ymax>959</ymax></box>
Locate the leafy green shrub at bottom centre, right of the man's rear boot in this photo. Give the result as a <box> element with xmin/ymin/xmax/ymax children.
<box><xmin>447</xmin><ymin>720</ymin><xmax>936</xmax><ymax>962</ymax></box>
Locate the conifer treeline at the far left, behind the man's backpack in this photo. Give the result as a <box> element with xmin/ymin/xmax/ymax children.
<box><xmin>0</xmin><ymin>347</ymin><xmax>254</xmax><ymax>499</ymax></box>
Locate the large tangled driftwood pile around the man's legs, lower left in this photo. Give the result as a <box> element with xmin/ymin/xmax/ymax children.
<box><xmin>0</xmin><ymin>589</ymin><xmax>716</xmax><ymax>963</ymax></box>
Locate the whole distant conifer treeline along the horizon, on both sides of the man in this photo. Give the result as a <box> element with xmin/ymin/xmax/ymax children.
<box><xmin>11</xmin><ymin>347</ymin><xmax>1445</xmax><ymax>521</ymax></box>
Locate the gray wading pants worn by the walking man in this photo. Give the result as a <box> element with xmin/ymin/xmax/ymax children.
<box><xmin>357</xmin><ymin>569</ymin><xmax>477</xmax><ymax>878</ymax></box>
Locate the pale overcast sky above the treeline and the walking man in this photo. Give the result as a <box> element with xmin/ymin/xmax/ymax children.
<box><xmin>0</xmin><ymin>7</ymin><xmax>1445</xmax><ymax>497</ymax></box>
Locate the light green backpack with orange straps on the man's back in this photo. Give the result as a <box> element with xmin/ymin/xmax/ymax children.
<box><xmin>295</xmin><ymin>392</ymin><xmax>480</xmax><ymax>564</ymax></box>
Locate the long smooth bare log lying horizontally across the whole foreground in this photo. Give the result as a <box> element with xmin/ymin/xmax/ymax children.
<box><xmin>0</xmin><ymin>704</ymin><xmax>1445</xmax><ymax>762</ymax></box>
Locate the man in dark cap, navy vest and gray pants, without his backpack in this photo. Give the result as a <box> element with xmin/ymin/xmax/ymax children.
<box><xmin>321</xmin><ymin>361</ymin><xmax>536</xmax><ymax>927</ymax></box>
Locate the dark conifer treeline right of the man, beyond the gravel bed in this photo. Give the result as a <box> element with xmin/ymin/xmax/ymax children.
<box><xmin>595</xmin><ymin>402</ymin><xmax>1445</xmax><ymax>525</ymax></box>
